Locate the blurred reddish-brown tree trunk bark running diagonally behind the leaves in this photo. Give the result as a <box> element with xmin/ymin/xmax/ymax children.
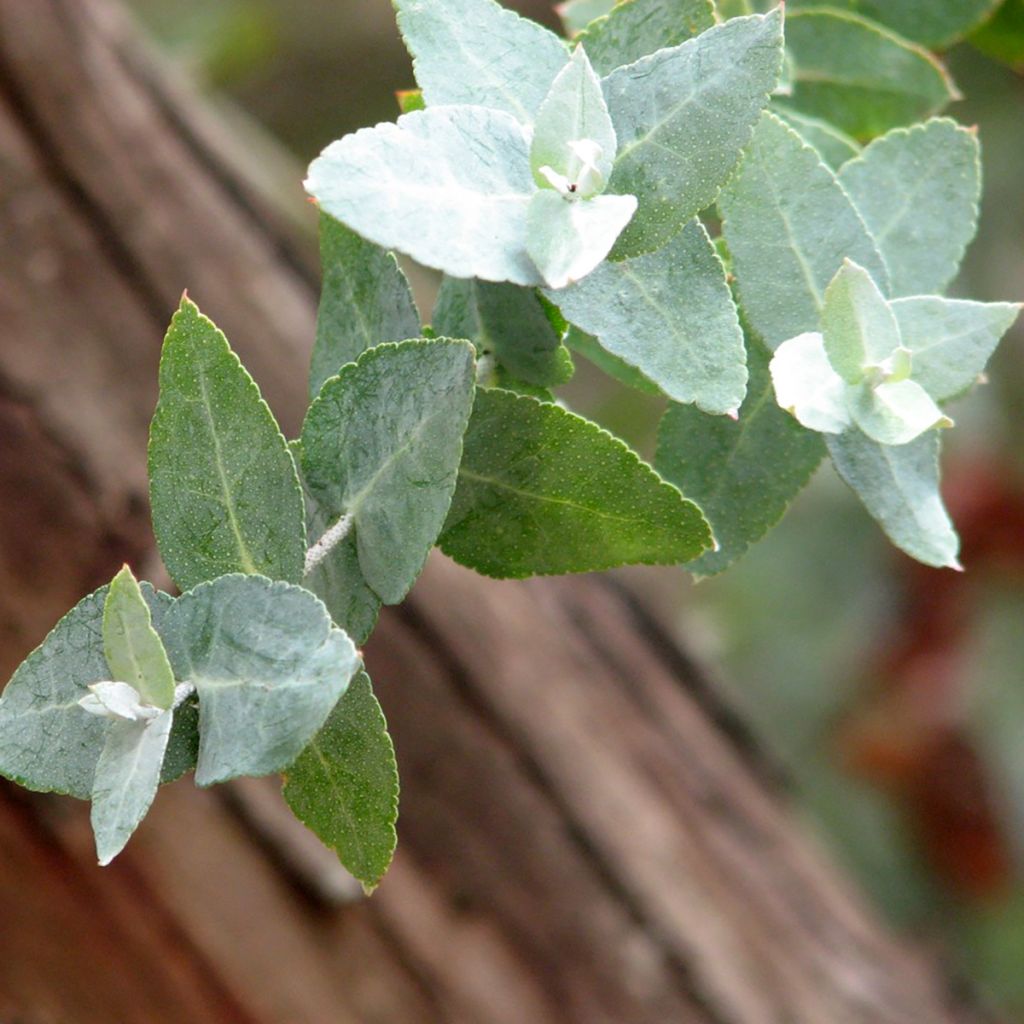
<box><xmin>0</xmin><ymin>0</ymin><xmax>995</xmax><ymax>1024</ymax></box>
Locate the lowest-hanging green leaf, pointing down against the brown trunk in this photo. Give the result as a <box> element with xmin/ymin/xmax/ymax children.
<box><xmin>285</xmin><ymin>672</ymin><xmax>398</xmax><ymax>891</ymax></box>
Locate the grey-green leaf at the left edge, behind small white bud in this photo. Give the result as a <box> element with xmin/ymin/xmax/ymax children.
<box><xmin>0</xmin><ymin>583</ymin><xmax>171</xmax><ymax>800</ymax></box>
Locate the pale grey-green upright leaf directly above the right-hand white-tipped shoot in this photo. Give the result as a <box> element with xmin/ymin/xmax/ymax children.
<box><xmin>719</xmin><ymin>114</ymin><xmax>888</xmax><ymax>349</ymax></box>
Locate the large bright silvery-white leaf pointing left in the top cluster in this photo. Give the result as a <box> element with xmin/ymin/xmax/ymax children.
<box><xmin>305</xmin><ymin>108</ymin><xmax>543</xmax><ymax>285</ymax></box>
